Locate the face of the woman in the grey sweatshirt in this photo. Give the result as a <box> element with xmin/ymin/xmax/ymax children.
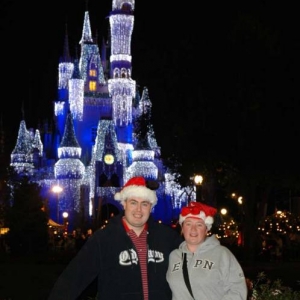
<box><xmin>182</xmin><ymin>217</ymin><xmax>207</xmax><ymax>246</ymax></box>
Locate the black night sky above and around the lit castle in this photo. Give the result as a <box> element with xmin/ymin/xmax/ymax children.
<box><xmin>0</xmin><ymin>0</ymin><xmax>300</xmax><ymax>180</ymax></box>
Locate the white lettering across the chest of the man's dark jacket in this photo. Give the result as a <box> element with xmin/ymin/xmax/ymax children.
<box><xmin>119</xmin><ymin>249</ymin><xmax>164</xmax><ymax>266</ymax></box>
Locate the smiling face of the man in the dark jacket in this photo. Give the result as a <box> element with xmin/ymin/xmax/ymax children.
<box><xmin>123</xmin><ymin>197</ymin><xmax>152</xmax><ymax>229</ymax></box>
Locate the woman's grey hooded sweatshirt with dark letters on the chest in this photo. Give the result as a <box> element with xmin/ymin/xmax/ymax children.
<box><xmin>167</xmin><ymin>235</ymin><xmax>247</xmax><ymax>300</ymax></box>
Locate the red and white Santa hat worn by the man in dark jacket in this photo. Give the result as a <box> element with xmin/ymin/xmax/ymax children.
<box><xmin>115</xmin><ymin>176</ymin><xmax>157</xmax><ymax>206</ymax></box>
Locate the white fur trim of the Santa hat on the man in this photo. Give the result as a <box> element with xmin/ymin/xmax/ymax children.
<box><xmin>115</xmin><ymin>185</ymin><xmax>157</xmax><ymax>206</ymax></box>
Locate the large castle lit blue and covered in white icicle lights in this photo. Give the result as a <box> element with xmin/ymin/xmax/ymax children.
<box><xmin>11</xmin><ymin>0</ymin><xmax>195</xmax><ymax>228</ymax></box>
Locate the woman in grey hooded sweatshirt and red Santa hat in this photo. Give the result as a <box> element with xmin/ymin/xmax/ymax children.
<box><xmin>167</xmin><ymin>202</ymin><xmax>247</xmax><ymax>300</ymax></box>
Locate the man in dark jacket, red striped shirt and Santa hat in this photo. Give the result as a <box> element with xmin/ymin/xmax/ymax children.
<box><xmin>48</xmin><ymin>177</ymin><xmax>182</xmax><ymax>300</ymax></box>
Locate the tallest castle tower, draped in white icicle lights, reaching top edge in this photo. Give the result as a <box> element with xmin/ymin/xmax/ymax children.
<box><xmin>108</xmin><ymin>0</ymin><xmax>136</xmax><ymax>130</ymax></box>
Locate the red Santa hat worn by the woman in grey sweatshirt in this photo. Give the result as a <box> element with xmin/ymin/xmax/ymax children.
<box><xmin>179</xmin><ymin>202</ymin><xmax>217</xmax><ymax>230</ymax></box>
